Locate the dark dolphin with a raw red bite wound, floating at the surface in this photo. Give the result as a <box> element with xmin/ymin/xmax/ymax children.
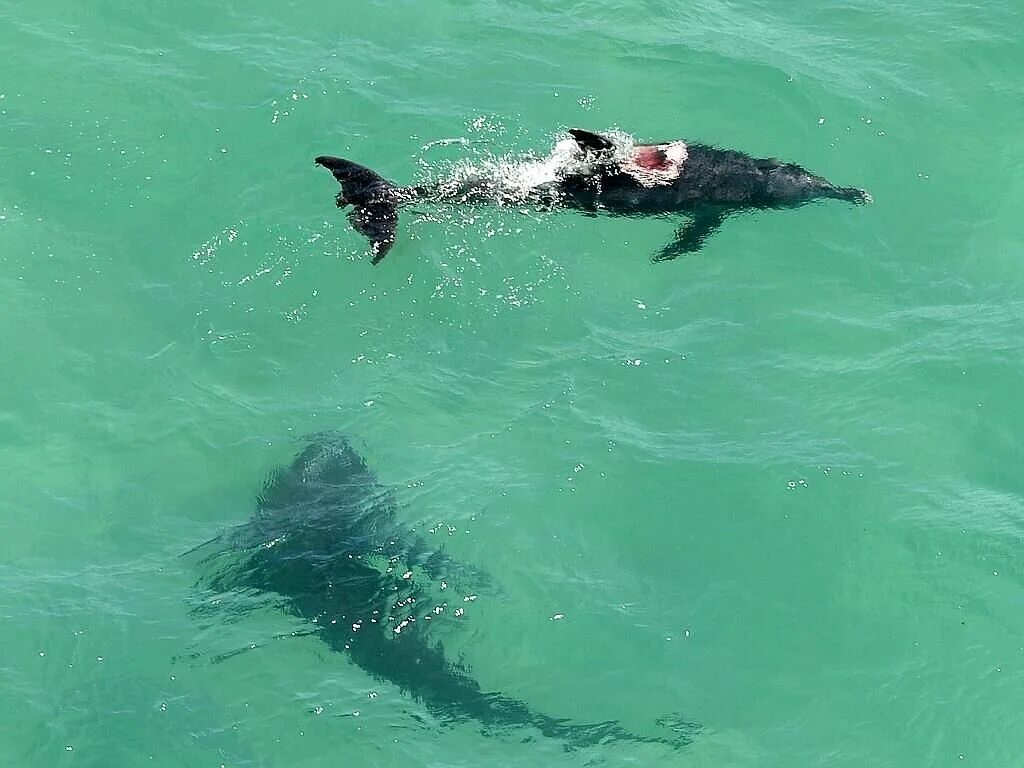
<box><xmin>314</xmin><ymin>128</ymin><xmax>871</xmax><ymax>264</ymax></box>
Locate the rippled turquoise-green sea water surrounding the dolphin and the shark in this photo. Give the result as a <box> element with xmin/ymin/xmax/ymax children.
<box><xmin>0</xmin><ymin>0</ymin><xmax>1024</xmax><ymax>768</ymax></box>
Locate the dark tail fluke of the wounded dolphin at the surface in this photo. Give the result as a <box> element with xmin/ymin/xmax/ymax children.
<box><xmin>314</xmin><ymin>155</ymin><xmax>401</xmax><ymax>264</ymax></box>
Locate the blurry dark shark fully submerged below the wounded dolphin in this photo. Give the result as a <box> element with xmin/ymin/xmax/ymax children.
<box><xmin>192</xmin><ymin>433</ymin><xmax>700</xmax><ymax>750</ymax></box>
